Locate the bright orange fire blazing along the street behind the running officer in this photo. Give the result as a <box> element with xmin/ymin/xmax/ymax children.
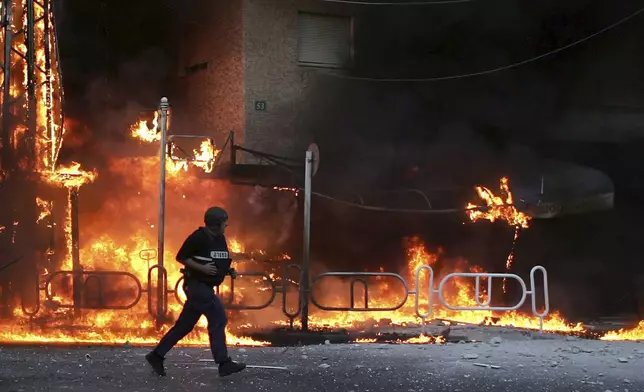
<box><xmin>0</xmin><ymin>0</ymin><xmax>644</xmax><ymax>346</ymax></box>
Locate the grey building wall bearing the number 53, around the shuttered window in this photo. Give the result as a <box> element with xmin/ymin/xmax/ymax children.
<box><xmin>244</xmin><ymin>0</ymin><xmax>351</xmax><ymax>162</ymax></box>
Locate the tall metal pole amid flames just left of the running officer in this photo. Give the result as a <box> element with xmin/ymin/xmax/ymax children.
<box><xmin>157</xmin><ymin>97</ymin><xmax>169</xmax><ymax>326</ymax></box>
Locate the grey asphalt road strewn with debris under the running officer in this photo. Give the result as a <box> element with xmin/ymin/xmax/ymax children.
<box><xmin>0</xmin><ymin>338</ymin><xmax>644</xmax><ymax>392</ymax></box>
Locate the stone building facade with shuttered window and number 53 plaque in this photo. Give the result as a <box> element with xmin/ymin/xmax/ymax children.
<box><xmin>174</xmin><ymin>0</ymin><xmax>355</xmax><ymax>162</ymax></box>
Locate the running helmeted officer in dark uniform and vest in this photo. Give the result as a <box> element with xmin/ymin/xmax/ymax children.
<box><xmin>146</xmin><ymin>207</ymin><xmax>245</xmax><ymax>376</ymax></box>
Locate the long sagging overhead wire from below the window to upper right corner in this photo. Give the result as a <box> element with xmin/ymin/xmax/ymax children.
<box><xmin>325</xmin><ymin>4</ymin><xmax>644</xmax><ymax>83</ymax></box>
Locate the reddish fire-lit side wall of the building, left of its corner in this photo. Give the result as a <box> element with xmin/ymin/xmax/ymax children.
<box><xmin>173</xmin><ymin>0</ymin><xmax>244</xmax><ymax>152</ymax></box>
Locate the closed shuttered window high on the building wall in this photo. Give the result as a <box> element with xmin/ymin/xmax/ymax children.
<box><xmin>297</xmin><ymin>12</ymin><xmax>353</xmax><ymax>68</ymax></box>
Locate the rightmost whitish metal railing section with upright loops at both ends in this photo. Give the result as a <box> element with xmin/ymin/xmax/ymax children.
<box><xmin>415</xmin><ymin>265</ymin><xmax>550</xmax><ymax>331</ymax></box>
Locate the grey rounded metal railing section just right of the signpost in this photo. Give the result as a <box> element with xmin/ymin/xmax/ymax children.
<box><xmin>310</xmin><ymin>272</ymin><xmax>417</xmax><ymax>312</ymax></box>
